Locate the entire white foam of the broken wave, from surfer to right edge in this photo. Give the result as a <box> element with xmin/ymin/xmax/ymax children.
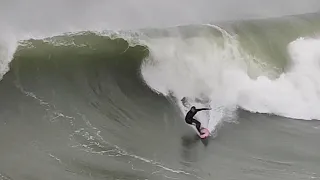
<box><xmin>141</xmin><ymin>27</ymin><xmax>320</xmax><ymax>131</ymax></box>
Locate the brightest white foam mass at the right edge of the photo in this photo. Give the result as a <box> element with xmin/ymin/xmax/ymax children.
<box><xmin>238</xmin><ymin>38</ymin><xmax>320</xmax><ymax>120</ymax></box>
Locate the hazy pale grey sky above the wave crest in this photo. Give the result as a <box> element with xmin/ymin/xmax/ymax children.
<box><xmin>0</xmin><ymin>0</ymin><xmax>320</xmax><ymax>35</ymax></box>
